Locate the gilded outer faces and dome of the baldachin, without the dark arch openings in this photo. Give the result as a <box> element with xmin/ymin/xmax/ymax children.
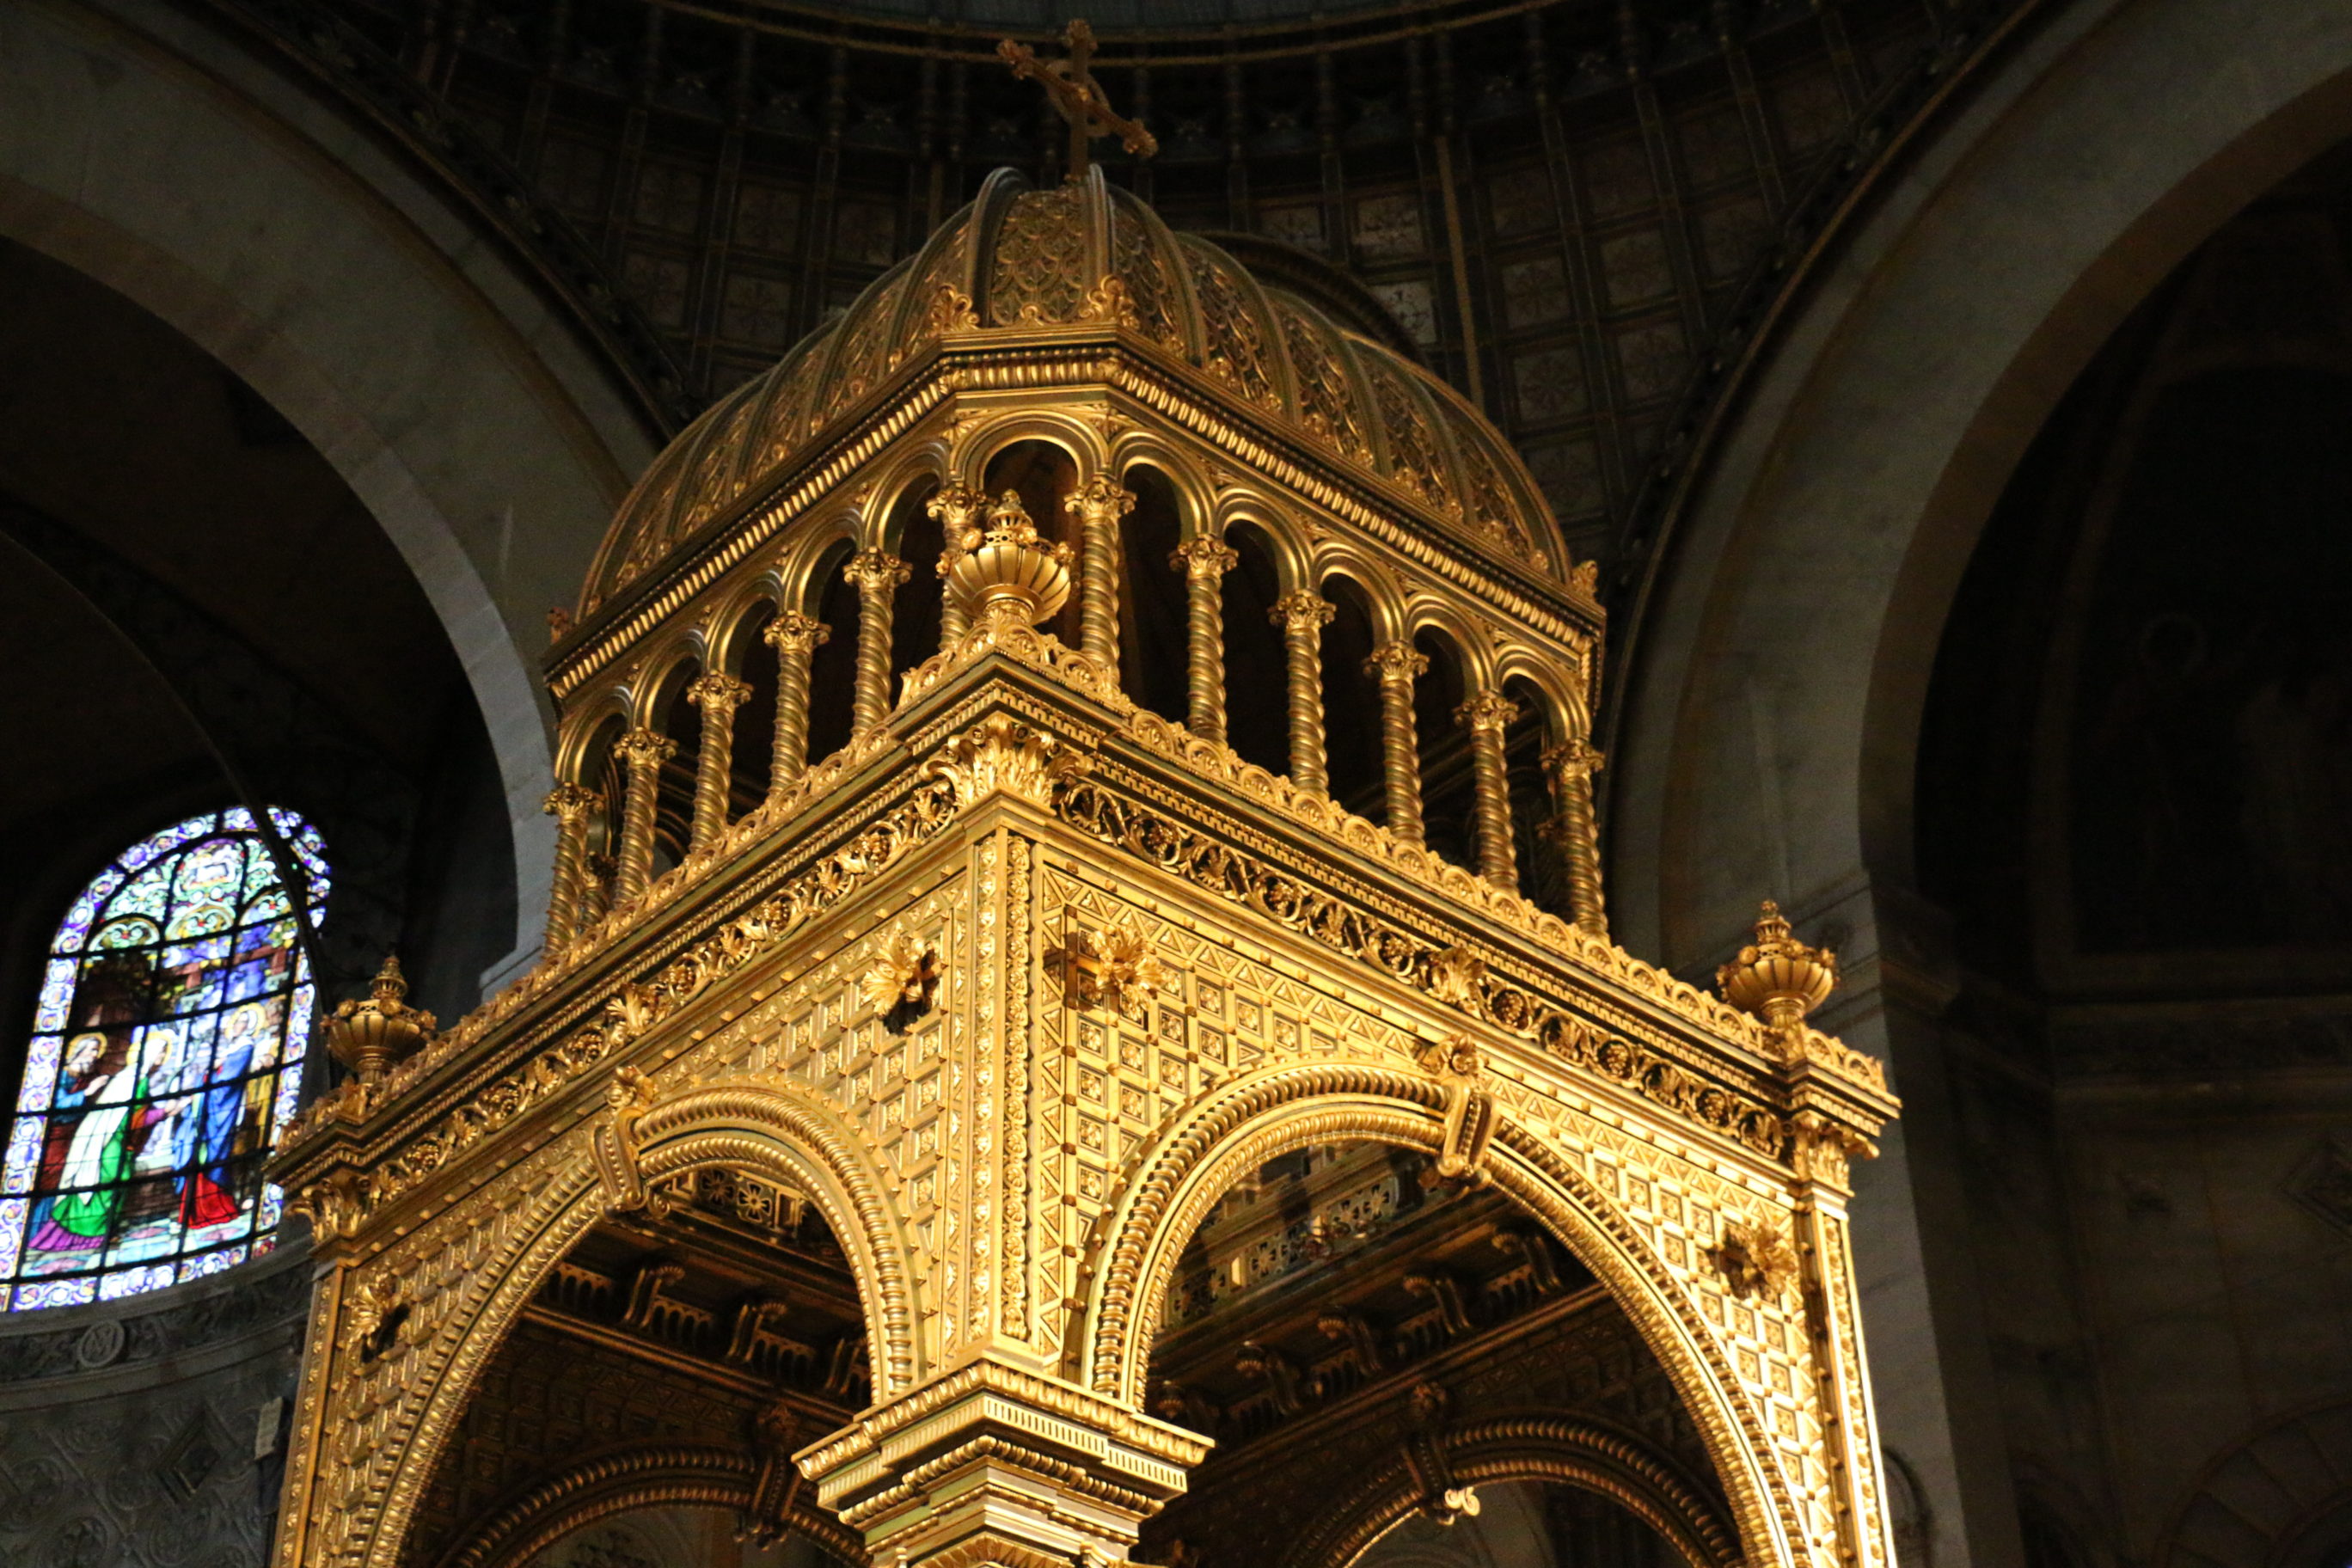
<box><xmin>278</xmin><ymin>174</ymin><xmax>1893</xmax><ymax>1568</ymax></box>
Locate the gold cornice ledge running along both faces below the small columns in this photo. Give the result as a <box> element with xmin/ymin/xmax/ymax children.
<box><xmin>275</xmin><ymin>648</ymin><xmax>1896</xmax><ymax>1240</ymax></box>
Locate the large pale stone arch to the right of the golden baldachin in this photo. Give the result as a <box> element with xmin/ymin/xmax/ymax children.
<box><xmin>1604</xmin><ymin>0</ymin><xmax>2352</xmax><ymax>966</ymax></box>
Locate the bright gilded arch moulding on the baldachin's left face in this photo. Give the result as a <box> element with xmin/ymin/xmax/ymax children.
<box><xmin>352</xmin><ymin>1081</ymin><xmax>927</xmax><ymax>1568</ymax></box>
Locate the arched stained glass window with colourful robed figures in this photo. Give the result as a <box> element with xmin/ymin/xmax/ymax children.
<box><xmin>0</xmin><ymin>809</ymin><xmax>327</xmax><ymax>1309</ymax></box>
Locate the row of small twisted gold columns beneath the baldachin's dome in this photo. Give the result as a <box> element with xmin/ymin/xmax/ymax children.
<box><xmin>546</xmin><ymin>475</ymin><xmax>1607</xmax><ymax>952</ymax></box>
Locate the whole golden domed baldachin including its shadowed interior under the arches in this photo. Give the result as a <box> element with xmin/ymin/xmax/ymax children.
<box><xmin>275</xmin><ymin>128</ymin><xmax>1893</xmax><ymax>1568</ymax></box>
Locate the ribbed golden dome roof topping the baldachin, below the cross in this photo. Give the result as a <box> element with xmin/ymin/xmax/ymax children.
<box><xmin>584</xmin><ymin>169</ymin><xmax>1569</xmax><ymax>614</ymax></box>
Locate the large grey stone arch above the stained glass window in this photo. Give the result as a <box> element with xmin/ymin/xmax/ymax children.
<box><xmin>0</xmin><ymin>7</ymin><xmax>654</xmax><ymax>968</ymax></box>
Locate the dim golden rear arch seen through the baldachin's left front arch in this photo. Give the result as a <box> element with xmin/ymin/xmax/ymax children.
<box><xmin>438</xmin><ymin>1443</ymin><xmax>866</xmax><ymax>1568</ymax></box>
